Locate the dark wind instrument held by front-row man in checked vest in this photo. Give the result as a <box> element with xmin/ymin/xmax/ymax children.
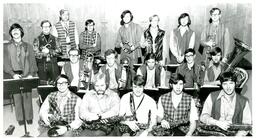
<box><xmin>151</xmin><ymin>118</ymin><xmax>189</xmax><ymax>136</ymax></box>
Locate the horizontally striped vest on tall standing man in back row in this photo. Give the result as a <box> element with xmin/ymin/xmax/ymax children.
<box><xmin>55</xmin><ymin>21</ymin><xmax>76</xmax><ymax>54</ymax></box>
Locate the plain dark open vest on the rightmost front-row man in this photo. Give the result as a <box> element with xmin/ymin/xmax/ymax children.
<box><xmin>211</xmin><ymin>91</ymin><xmax>248</xmax><ymax>124</ymax></box>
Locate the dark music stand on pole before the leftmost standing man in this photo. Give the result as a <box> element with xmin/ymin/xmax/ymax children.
<box><xmin>4</xmin><ymin>77</ymin><xmax>39</xmax><ymax>137</ymax></box>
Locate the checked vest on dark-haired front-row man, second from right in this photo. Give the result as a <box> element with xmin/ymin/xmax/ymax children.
<box><xmin>161</xmin><ymin>93</ymin><xmax>192</xmax><ymax>120</ymax></box>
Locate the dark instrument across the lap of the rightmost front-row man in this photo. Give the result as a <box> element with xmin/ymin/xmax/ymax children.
<box><xmin>197</xmin><ymin>122</ymin><xmax>252</xmax><ymax>136</ymax></box>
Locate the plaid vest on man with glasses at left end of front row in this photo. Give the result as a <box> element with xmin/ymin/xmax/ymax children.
<box><xmin>49</xmin><ymin>92</ymin><xmax>78</xmax><ymax>124</ymax></box>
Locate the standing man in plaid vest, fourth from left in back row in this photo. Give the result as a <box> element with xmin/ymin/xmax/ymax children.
<box><xmin>79</xmin><ymin>19</ymin><xmax>101</xmax><ymax>59</ymax></box>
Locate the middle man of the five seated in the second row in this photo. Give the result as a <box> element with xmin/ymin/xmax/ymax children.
<box><xmin>137</xmin><ymin>53</ymin><xmax>162</xmax><ymax>88</ymax></box>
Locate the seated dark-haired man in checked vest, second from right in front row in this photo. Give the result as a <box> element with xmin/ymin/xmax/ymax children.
<box><xmin>157</xmin><ymin>74</ymin><xmax>198</xmax><ymax>136</ymax></box>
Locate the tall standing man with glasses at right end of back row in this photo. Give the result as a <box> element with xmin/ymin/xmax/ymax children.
<box><xmin>200</xmin><ymin>8</ymin><xmax>234</xmax><ymax>66</ymax></box>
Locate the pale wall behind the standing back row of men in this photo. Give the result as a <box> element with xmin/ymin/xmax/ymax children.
<box><xmin>3</xmin><ymin>0</ymin><xmax>252</xmax><ymax>62</ymax></box>
